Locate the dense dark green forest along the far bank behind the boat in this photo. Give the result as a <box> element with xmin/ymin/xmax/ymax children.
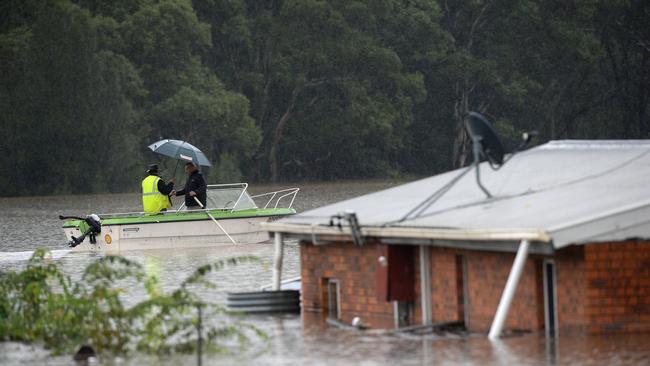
<box><xmin>0</xmin><ymin>0</ymin><xmax>650</xmax><ymax>195</ymax></box>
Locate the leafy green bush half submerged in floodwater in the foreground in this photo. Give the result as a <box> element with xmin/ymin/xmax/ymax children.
<box><xmin>0</xmin><ymin>249</ymin><xmax>266</xmax><ymax>354</ymax></box>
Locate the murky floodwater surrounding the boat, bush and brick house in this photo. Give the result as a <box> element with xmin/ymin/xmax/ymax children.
<box><xmin>0</xmin><ymin>181</ymin><xmax>650</xmax><ymax>365</ymax></box>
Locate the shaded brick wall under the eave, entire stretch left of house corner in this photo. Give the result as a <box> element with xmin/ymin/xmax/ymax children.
<box><xmin>300</xmin><ymin>243</ymin><xmax>544</xmax><ymax>332</ymax></box>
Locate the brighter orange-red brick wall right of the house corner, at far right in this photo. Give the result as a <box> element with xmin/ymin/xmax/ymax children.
<box><xmin>585</xmin><ymin>241</ymin><xmax>650</xmax><ymax>333</ymax></box>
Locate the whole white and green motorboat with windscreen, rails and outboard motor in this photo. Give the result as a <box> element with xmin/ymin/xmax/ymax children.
<box><xmin>62</xmin><ymin>183</ymin><xmax>299</xmax><ymax>252</ymax></box>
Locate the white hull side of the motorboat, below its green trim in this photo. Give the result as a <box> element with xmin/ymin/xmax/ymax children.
<box><xmin>63</xmin><ymin>216</ymin><xmax>278</xmax><ymax>252</ymax></box>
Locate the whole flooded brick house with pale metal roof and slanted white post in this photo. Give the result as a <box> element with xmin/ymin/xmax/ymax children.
<box><xmin>266</xmin><ymin>141</ymin><xmax>650</xmax><ymax>338</ymax></box>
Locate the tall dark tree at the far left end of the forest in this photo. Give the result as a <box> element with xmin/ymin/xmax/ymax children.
<box><xmin>4</xmin><ymin>1</ymin><xmax>143</xmax><ymax>194</ymax></box>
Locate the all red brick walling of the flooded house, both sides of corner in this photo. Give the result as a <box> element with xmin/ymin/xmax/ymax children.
<box><xmin>300</xmin><ymin>242</ymin><xmax>650</xmax><ymax>333</ymax></box>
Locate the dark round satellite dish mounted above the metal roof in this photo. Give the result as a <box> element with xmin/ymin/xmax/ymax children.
<box><xmin>465</xmin><ymin>112</ymin><xmax>503</xmax><ymax>166</ymax></box>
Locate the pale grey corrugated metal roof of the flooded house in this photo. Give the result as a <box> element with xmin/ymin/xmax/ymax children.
<box><xmin>267</xmin><ymin>140</ymin><xmax>650</xmax><ymax>248</ymax></box>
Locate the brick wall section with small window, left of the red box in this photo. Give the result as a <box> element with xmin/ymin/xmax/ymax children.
<box><xmin>300</xmin><ymin>242</ymin><xmax>394</xmax><ymax>328</ymax></box>
